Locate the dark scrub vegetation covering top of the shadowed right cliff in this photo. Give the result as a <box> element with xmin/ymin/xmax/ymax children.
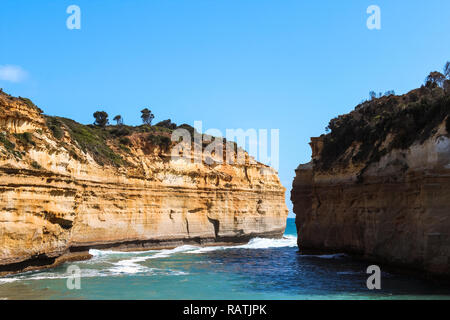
<box><xmin>315</xmin><ymin>62</ymin><xmax>450</xmax><ymax>170</ymax></box>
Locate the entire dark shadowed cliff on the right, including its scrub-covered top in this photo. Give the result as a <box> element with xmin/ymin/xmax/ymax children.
<box><xmin>291</xmin><ymin>87</ymin><xmax>450</xmax><ymax>277</ymax></box>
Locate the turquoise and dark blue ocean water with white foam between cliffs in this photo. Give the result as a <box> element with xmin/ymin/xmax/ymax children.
<box><xmin>0</xmin><ymin>219</ymin><xmax>450</xmax><ymax>299</ymax></box>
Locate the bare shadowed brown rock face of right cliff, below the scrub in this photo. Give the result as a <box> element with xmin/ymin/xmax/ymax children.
<box><xmin>291</xmin><ymin>89</ymin><xmax>450</xmax><ymax>278</ymax></box>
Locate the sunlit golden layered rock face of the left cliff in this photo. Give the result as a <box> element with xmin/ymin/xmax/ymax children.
<box><xmin>0</xmin><ymin>94</ymin><xmax>287</xmax><ymax>272</ymax></box>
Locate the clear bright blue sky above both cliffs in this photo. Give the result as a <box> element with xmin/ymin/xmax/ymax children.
<box><xmin>0</xmin><ymin>0</ymin><xmax>450</xmax><ymax>218</ymax></box>
